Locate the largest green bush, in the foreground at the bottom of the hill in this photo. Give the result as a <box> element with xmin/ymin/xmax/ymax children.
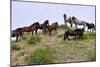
<box><xmin>25</xmin><ymin>48</ymin><xmax>55</xmax><ymax>64</ymax></box>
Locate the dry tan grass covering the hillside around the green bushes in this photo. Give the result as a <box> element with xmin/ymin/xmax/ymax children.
<box><xmin>11</xmin><ymin>29</ymin><xmax>96</xmax><ymax>65</ymax></box>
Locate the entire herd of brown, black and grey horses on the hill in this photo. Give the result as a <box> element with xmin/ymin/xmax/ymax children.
<box><xmin>11</xmin><ymin>14</ymin><xmax>95</xmax><ymax>41</ymax></box>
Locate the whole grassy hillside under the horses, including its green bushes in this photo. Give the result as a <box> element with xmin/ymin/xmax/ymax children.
<box><xmin>11</xmin><ymin>26</ymin><xmax>96</xmax><ymax>65</ymax></box>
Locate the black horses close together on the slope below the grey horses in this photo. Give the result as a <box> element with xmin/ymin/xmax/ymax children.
<box><xmin>64</xmin><ymin>28</ymin><xmax>84</xmax><ymax>40</ymax></box>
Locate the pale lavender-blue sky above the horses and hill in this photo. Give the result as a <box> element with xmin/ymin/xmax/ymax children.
<box><xmin>11</xmin><ymin>1</ymin><xmax>95</xmax><ymax>29</ymax></box>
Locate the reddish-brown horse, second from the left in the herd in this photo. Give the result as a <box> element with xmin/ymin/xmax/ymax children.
<box><xmin>22</xmin><ymin>22</ymin><xmax>39</xmax><ymax>35</ymax></box>
